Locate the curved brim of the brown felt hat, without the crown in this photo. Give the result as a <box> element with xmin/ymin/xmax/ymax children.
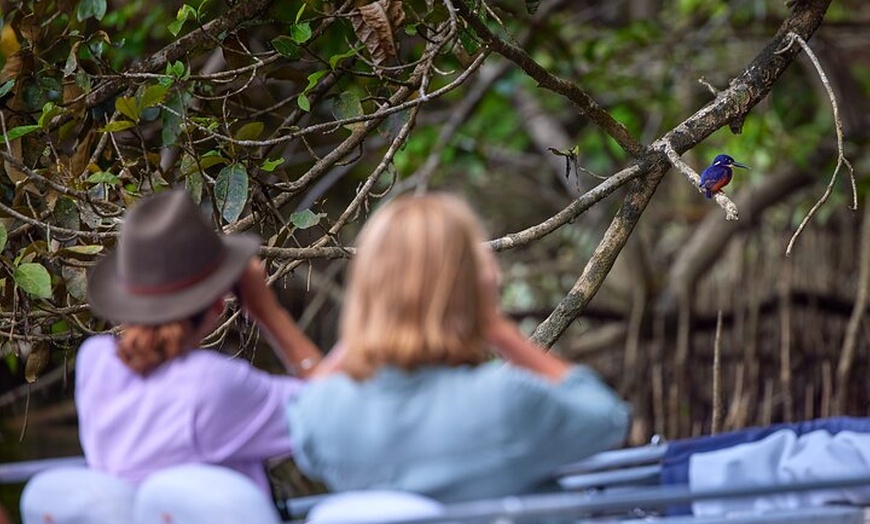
<box><xmin>88</xmin><ymin>234</ymin><xmax>260</xmax><ymax>325</ymax></box>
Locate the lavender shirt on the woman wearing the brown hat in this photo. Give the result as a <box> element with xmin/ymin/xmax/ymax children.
<box><xmin>75</xmin><ymin>335</ymin><xmax>303</xmax><ymax>493</ymax></box>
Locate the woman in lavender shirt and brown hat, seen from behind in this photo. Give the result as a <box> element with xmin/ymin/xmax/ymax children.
<box><xmin>75</xmin><ymin>190</ymin><xmax>321</xmax><ymax>493</ymax></box>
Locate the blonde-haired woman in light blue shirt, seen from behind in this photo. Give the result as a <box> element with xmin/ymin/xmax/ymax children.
<box><xmin>288</xmin><ymin>194</ymin><xmax>629</xmax><ymax>502</ymax></box>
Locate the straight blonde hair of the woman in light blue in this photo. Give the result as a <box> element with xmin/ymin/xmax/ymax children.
<box><xmin>341</xmin><ymin>194</ymin><xmax>487</xmax><ymax>380</ymax></box>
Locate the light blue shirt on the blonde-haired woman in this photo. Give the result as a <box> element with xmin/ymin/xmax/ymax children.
<box><xmin>288</xmin><ymin>362</ymin><xmax>630</xmax><ymax>502</ymax></box>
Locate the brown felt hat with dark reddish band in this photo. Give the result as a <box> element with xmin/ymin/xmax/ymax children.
<box><xmin>88</xmin><ymin>189</ymin><xmax>260</xmax><ymax>325</ymax></box>
